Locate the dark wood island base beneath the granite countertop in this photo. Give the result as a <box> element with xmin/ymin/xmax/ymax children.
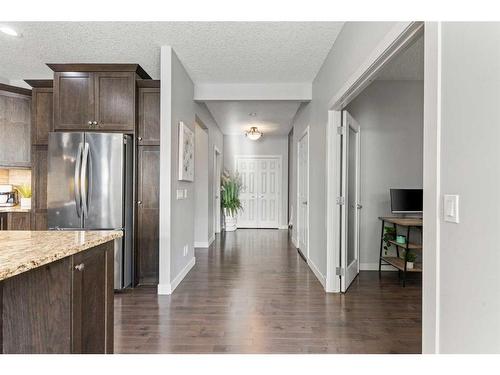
<box><xmin>0</xmin><ymin>242</ymin><xmax>114</xmax><ymax>353</ymax></box>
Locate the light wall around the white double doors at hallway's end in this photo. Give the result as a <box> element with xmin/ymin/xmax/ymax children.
<box><xmin>223</xmin><ymin>135</ymin><xmax>288</xmax><ymax>226</ymax></box>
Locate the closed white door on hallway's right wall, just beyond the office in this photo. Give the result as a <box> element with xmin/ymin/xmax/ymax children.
<box><xmin>297</xmin><ymin>132</ymin><xmax>309</xmax><ymax>259</ymax></box>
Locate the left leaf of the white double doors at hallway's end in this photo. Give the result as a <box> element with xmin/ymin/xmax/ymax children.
<box><xmin>236</xmin><ymin>159</ymin><xmax>258</xmax><ymax>228</ymax></box>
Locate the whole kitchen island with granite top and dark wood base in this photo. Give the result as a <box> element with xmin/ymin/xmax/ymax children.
<box><xmin>0</xmin><ymin>231</ymin><xmax>123</xmax><ymax>353</ymax></box>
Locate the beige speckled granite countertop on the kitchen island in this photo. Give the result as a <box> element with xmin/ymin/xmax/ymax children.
<box><xmin>0</xmin><ymin>230</ymin><xmax>123</xmax><ymax>281</ymax></box>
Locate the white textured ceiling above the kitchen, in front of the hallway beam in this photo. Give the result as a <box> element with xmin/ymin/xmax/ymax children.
<box><xmin>0</xmin><ymin>21</ymin><xmax>343</xmax><ymax>83</ymax></box>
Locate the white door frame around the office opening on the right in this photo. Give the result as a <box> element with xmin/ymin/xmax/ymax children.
<box><xmin>325</xmin><ymin>22</ymin><xmax>424</xmax><ymax>293</ymax></box>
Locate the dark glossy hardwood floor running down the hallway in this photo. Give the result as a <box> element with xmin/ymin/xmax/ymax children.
<box><xmin>115</xmin><ymin>229</ymin><xmax>422</xmax><ymax>353</ymax></box>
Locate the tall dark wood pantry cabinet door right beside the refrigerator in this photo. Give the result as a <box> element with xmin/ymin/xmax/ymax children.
<box><xmin>136</xmin><ymin>146</ymin><xmax>160</xmax><ymax>285</ymax></box>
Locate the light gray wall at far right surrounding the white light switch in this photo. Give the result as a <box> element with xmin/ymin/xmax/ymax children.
<box><xmin>438</xmin><ymin>23</ymin><xmax>500</xmax><ymax>353</ymax></box>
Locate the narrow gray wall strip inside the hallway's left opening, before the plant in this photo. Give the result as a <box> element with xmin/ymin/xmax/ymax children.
<box><xmin>194</xmin><ymin>120</ymin><xmax>212</xmax><ymax>247</ymax></box>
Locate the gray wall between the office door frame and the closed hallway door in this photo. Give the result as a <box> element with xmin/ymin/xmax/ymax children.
<box><xmin>294</xmin><ymin>22</ymin><xmax>396</xmax><ymax>277</ymax></box>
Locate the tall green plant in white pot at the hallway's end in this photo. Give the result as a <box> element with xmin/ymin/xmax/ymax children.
<box><xmin>221</xmin><ymin>171</ymin><xmax>242</xmax><ymax>232</ymax></box>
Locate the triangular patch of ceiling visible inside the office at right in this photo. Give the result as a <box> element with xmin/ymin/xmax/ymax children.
<box><xmin>377</xmin><ymin>36</ymin><xmax>424</xmax><ymax>81</ymax></box>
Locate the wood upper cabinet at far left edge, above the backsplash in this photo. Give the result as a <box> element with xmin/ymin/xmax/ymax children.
<box><xmin>0</xmin><ymin>85</ymin><xmax>31</xmax><ymax>168</ymax></box>
